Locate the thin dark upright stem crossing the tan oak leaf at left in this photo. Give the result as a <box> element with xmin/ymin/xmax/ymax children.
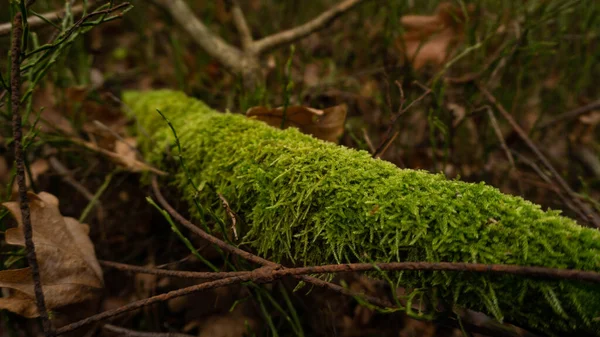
<box><xmin>10</xmin><ymin>6</ymin><xmax>54</xmax><ymax>337</ymax></box>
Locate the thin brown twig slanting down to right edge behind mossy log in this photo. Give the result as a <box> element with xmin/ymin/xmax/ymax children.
<box><xmin>477</xmin><ymin>83</ymin><xmax>600</xmax><ymax>228</ymax></box>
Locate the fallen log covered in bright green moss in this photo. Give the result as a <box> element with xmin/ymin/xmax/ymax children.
<box><xmin>124</xmin><ymin>91</ymin><xmax>600</xmax><ymax>335</ymax></box>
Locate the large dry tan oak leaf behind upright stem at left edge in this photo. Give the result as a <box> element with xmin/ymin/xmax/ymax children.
<box><xmin>0</xmin><ymin>192</ymin><xmax>104</xmax><ymax>318</ymax></box>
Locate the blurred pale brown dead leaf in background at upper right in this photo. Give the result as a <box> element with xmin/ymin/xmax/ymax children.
<box><xmin>397</xmin><ymin>2</ymin><xmax>474</xmax><ymax>69</ymax></box>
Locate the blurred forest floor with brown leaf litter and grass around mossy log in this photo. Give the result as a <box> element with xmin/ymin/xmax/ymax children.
<box><xmin>0</xmin><ymin>0</ymin><xmax>600</xmax><ymax>337</ymax></box>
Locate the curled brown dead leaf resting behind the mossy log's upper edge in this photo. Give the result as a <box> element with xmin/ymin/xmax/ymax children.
<box><xmin>246</xmin><ymin>104</ymin><xmax>348</xmax><ymax>143</ymax></box>
